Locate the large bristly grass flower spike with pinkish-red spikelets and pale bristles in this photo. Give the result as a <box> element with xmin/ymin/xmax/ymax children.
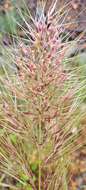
<box><xmin>0</xmin><ymin>1</ymin><xmax>84</xmax><ymax>190</ymax></box>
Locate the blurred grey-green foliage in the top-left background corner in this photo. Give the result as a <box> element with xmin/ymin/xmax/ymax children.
<box><xmin>0</xmin><ymin>0</ymin><xmax>26</xmax><ymax>36</ymax></box>
